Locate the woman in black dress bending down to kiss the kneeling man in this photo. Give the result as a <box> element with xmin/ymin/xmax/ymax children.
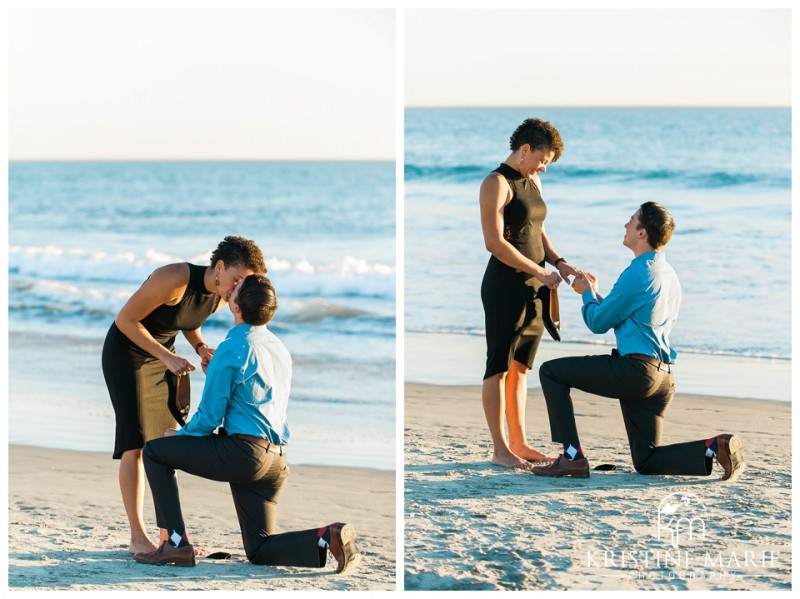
<box><xmin>103</xmin><ymin>236</ymin><xmax>267</xmax><ymax>554</ymax></box>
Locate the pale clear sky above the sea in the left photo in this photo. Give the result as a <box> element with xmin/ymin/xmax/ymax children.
<box><xmin>8</xmin><ymin>8</ymin><xmax>396</xmax><ymax>161</ymax></box>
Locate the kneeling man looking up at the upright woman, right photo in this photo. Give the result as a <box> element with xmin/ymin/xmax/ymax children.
<box><xmin>533</xmin><ymin>202</ymin><xmax>745</xmax><ymax>480</ymax></box>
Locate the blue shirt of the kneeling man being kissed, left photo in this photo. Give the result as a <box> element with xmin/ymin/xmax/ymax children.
<box><xmin>177</xmin><ymin>323</ymin><xmax>292</xmax><ymax>444</ymax></box>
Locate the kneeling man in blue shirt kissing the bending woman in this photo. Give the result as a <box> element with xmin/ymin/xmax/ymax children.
<box><xmin>134</xmin><ymin>275</ymin><xmax>361</xmax><ymax>573</ymax></box>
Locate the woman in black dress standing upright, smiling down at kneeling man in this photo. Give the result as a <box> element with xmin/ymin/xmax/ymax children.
<box><xmin>480</xmin><ymin>119</ymin><xmax>579</xmax><ymax>469</ymax></box>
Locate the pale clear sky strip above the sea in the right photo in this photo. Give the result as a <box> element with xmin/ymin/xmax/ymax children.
<box><xmin>404</xmin><ymin>8</ymin><xmax>792</xmax><ymax>106</ymax></box>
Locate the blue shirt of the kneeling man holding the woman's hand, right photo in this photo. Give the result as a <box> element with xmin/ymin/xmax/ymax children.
<box><xmin>581</xmin><ymin>251</ymin><xmax>682</xmax><ymax>363</ymax></box>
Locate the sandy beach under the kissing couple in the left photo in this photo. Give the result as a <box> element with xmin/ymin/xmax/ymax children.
<box><xmin>8</xmin><ymin>445</ymin><xmax>396</xmax><ymax>591</ymax></box>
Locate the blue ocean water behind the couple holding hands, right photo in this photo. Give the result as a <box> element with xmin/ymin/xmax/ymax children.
<box><xmin>404</xmin><ymin>108</ymin><xmax>792</xmax><ymax>399</ymax></box>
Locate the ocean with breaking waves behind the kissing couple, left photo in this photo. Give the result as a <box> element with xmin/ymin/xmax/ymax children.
<box><xmin>8</xmin><ymin>162</ymin><xmax>396</xmax><ymax>469</ymax></box>
